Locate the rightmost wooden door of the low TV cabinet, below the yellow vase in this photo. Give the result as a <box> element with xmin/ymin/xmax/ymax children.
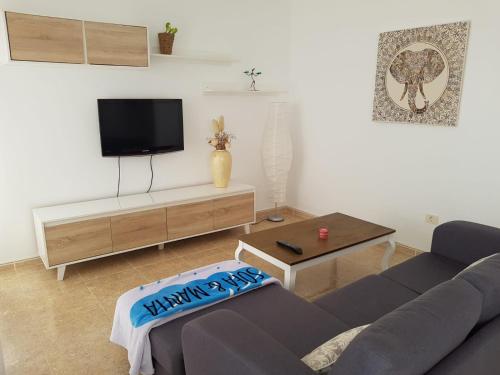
<box><xmin>214</xmin><ymin>193</ymin><xmax>255</xmax><ymax>229</ymax></box>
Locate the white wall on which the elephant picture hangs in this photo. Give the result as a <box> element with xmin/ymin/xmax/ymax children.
<box><xmin>289</xmin><ymin>0</ymin><xmax>500</xmax><ymax>250</ymax></box>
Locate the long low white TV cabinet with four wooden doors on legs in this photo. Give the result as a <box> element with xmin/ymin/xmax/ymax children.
<box><xmin>33</xmin><ymin>183</ymin><xmax>255</xmax><ymax>280</ymax></box>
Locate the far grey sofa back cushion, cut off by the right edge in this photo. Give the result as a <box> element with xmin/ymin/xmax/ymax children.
<box><xmin>456</xmin><ymin>254</ymin><xmax>500</xmax><ymax>323</ymax></box>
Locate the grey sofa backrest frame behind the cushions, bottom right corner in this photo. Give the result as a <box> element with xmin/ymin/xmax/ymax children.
<box><xmin>427</xmin><ymin>317</ymin><xmax>500</xmax><ymax>375</ymax></box>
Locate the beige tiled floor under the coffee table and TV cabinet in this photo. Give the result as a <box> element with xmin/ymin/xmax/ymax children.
<box><xmin>0</xmin><ymin>212</ymin><xmax>412</xmax><ymax>375</ymax></box>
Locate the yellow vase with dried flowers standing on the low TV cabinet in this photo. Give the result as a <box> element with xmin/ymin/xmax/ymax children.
<box><xmin>208</xmin><ymin>116</ymin><xmax>235</xmax><ymax>188</ymax></box>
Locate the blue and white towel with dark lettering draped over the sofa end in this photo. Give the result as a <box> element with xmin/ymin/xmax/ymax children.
<box><xmin>111</xmin><ymin>260</ymin><xmax>280</xmax><ymax>375</ymax></box>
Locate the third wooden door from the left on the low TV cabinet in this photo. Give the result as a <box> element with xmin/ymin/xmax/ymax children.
<box><xmin>167</xmin><ymin>201</ymin><xmax>214</xmax><ymax>240</ymax></box>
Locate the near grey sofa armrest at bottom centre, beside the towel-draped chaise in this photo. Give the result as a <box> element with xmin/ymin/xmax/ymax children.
<box><xmin>182</xmin><ymin>310</ymin><xmax>314</xmax><ymax>375</ymax></box>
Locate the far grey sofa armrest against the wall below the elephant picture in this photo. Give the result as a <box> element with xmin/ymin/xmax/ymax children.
<box><xmin>431</xmin><ymin>221</ymin><xmax>500</xmax><ymax>265</ymax></box>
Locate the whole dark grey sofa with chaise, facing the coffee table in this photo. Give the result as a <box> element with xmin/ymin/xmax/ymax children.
<box><xmin>150</xmin><ymin>221</ymin><xmax>500</xmax><ymax>375</ymax></box>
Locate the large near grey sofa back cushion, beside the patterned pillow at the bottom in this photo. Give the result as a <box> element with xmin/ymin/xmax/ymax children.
<box><xmin>330</xmin><ymin>280</ymin><xmax>482</xmax><ymax>375</ymax></box>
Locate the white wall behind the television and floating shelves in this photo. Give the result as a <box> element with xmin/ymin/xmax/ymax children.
<box><xmin>0</xmin><ymin>0</ymin><xmax>290</xmax><ymax>263</ymax></box>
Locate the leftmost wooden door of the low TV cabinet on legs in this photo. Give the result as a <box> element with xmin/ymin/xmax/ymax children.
<box><xmin>45</xmin><ymin>218</ymin><xmax>112</xmax><ymax>266</ymax></box>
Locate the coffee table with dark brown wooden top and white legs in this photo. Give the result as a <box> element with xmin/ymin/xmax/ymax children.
<box><xmin>235</xmin><ymin>213</ymin><xmax>396</xmax><ymax>290</ymax></box>
